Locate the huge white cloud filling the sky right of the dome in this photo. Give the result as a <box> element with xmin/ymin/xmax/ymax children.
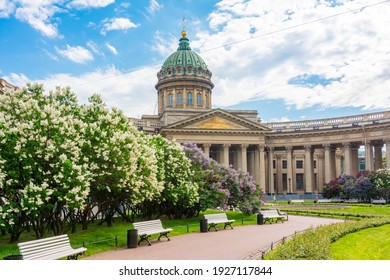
<box><xmin>191</xmin><ymin>0</ymin><xmax>390</xmax><ymax>114</ymax></box>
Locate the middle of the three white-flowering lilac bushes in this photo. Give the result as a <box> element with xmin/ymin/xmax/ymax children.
<box><xmin>81</xmin><ymin>95</ymin><xmax>162</xmax><ymax>226</ymax></box>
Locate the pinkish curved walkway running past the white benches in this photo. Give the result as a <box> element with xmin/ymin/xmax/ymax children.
<box><xmin>83</xmin><ymin>216</ymin><xmax>342</xmax><ymax>260</ymax></box>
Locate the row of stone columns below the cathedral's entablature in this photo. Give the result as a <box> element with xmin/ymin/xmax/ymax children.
<box><xmin>198</xmin><ymin>139</ymin><xmax>390</xmax><ymax>194</ymax></box>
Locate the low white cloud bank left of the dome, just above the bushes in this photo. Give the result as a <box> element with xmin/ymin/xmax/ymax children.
<box><xmin>5</xmin><ymin>66</ymin><xmax>159</xmax><ymax>118</ymax></box>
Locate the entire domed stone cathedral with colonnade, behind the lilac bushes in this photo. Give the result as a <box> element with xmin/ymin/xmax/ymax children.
<box><xmin>131</xmin><ymin>30</ymin><xmax>390</xmax><ymax>195</ymax></box>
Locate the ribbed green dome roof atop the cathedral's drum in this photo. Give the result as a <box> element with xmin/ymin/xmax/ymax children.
<box><xmin>161</xmin><ymin>36</ymin><xmax>207</xmax><ymax>70</ymax></box>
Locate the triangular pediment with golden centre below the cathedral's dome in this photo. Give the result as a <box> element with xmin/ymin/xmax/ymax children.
<box><xmin>166</xmin><ymin>109</ymin><xmax>269</xmax><ymax>131</ymax></box>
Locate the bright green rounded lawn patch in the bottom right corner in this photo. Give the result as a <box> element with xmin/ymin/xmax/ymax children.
<box><xmin>331</xmin><ymin>225</ymin><xmax>390</xmax><ymax>260</ymax></box>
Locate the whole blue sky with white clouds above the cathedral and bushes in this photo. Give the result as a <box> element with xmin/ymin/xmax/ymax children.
<box><xmin>0</xmin><ymin>0</ymin><xmax>390</xmax><ymax>122</ymax></box>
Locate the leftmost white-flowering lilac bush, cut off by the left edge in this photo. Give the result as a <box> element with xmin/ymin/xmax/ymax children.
<box><xmin>0</xmin><ymin>85</ymin><xmax>91</xmax><ymax>240</ymax></box>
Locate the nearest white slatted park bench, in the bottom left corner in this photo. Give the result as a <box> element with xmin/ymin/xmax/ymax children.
<box><xmin>18</xmin><ymin>234</ymin><xmax>87</xmax><ymax>260</ymax></box>
